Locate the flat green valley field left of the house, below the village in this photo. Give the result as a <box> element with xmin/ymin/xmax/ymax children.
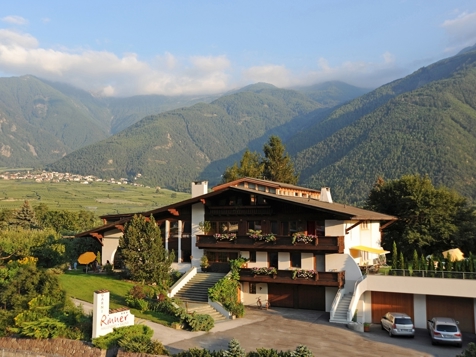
<box><xmin>0</xmin><ymin>180</ymin><xmax>190</xmax><ymax>216</ymax></box>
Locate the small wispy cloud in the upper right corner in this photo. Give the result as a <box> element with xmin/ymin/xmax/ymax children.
<box><xmin>441</xmin><ymin>12</ymin><xmax>476</xmax><ymax>52</ymax></box>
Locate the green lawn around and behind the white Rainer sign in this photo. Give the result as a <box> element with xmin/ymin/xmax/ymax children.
<box><xmin>60</xmin><ymin>266</ymin><xmax>178</xmax><ymax>326</ymax></box>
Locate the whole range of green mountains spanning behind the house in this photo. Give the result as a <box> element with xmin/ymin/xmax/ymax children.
<box><xmin>0</xmin><ymin>46</ymin><xmax>476</xmax><ymax>204</ymax></box>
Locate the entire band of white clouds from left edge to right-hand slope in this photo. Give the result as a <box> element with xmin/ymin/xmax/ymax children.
<box><xmin>0</xmin><ymin>29</ymin><xmax>408</xmax><ymax>96</ymax></box>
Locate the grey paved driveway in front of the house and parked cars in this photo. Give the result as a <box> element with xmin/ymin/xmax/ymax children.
<box><xmin>166</xmin><ymin>308</ymin><xmax>476</xmax><ymax>357</ymax></box>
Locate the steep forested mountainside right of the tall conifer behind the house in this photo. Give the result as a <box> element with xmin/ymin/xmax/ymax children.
<box><xmin>291</xmin><ymin>51</ymin><xmax>476</xmax><ymax>203</ymax></box>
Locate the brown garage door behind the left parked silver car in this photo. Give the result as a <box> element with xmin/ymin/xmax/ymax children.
<box><xmin>372</xmin><ymin>291</ymin><xmax>413</xmax><ymax>323</ymax></box>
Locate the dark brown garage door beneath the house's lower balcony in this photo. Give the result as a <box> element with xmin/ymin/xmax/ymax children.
<box><xmin>268</xmin><ymin>284</ymin><xmax>326</xmax><ymax>311</ymax></box>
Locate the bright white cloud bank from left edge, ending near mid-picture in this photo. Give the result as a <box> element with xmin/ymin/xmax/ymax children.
<box><xmin>0</xmin><ymin>29</ymin><xmax>230</xmax><ymax>96</ymax></box>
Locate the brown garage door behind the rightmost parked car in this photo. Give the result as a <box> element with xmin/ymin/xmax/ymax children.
<box><xmin>426</xmin><ymin>295</ymin><xmax>474</xmax><ymax>333</ymax></box>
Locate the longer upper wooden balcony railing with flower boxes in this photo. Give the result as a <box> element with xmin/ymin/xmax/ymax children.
<box><xmin>196</xmin><ymin>235</ymin><xmax>344</xmax><ymax>253</ymax></box>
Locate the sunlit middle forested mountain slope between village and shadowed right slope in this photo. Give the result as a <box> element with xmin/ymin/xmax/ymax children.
<box><xmin>49</xmin><ymin>85</ymin><xmax>320</xmax><ymax>190</ymax></box>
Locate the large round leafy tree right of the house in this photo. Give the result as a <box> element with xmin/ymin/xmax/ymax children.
<box><xmin>365</xmin><ymin>175</ymin><xmax>474</xmax><ymax>260</ymax></box>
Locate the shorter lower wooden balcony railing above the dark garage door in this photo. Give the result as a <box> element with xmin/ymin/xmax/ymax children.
<box><xmin>240</xmin><ymin>268</ymin><xmax>345</xmax><ymax>288</ymax></box>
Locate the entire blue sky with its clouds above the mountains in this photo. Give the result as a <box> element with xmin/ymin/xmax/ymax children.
<box><xmin>0</xmin><ymin>0</ymin><xmax>476</xmax><ymax>96</ymax></box>
